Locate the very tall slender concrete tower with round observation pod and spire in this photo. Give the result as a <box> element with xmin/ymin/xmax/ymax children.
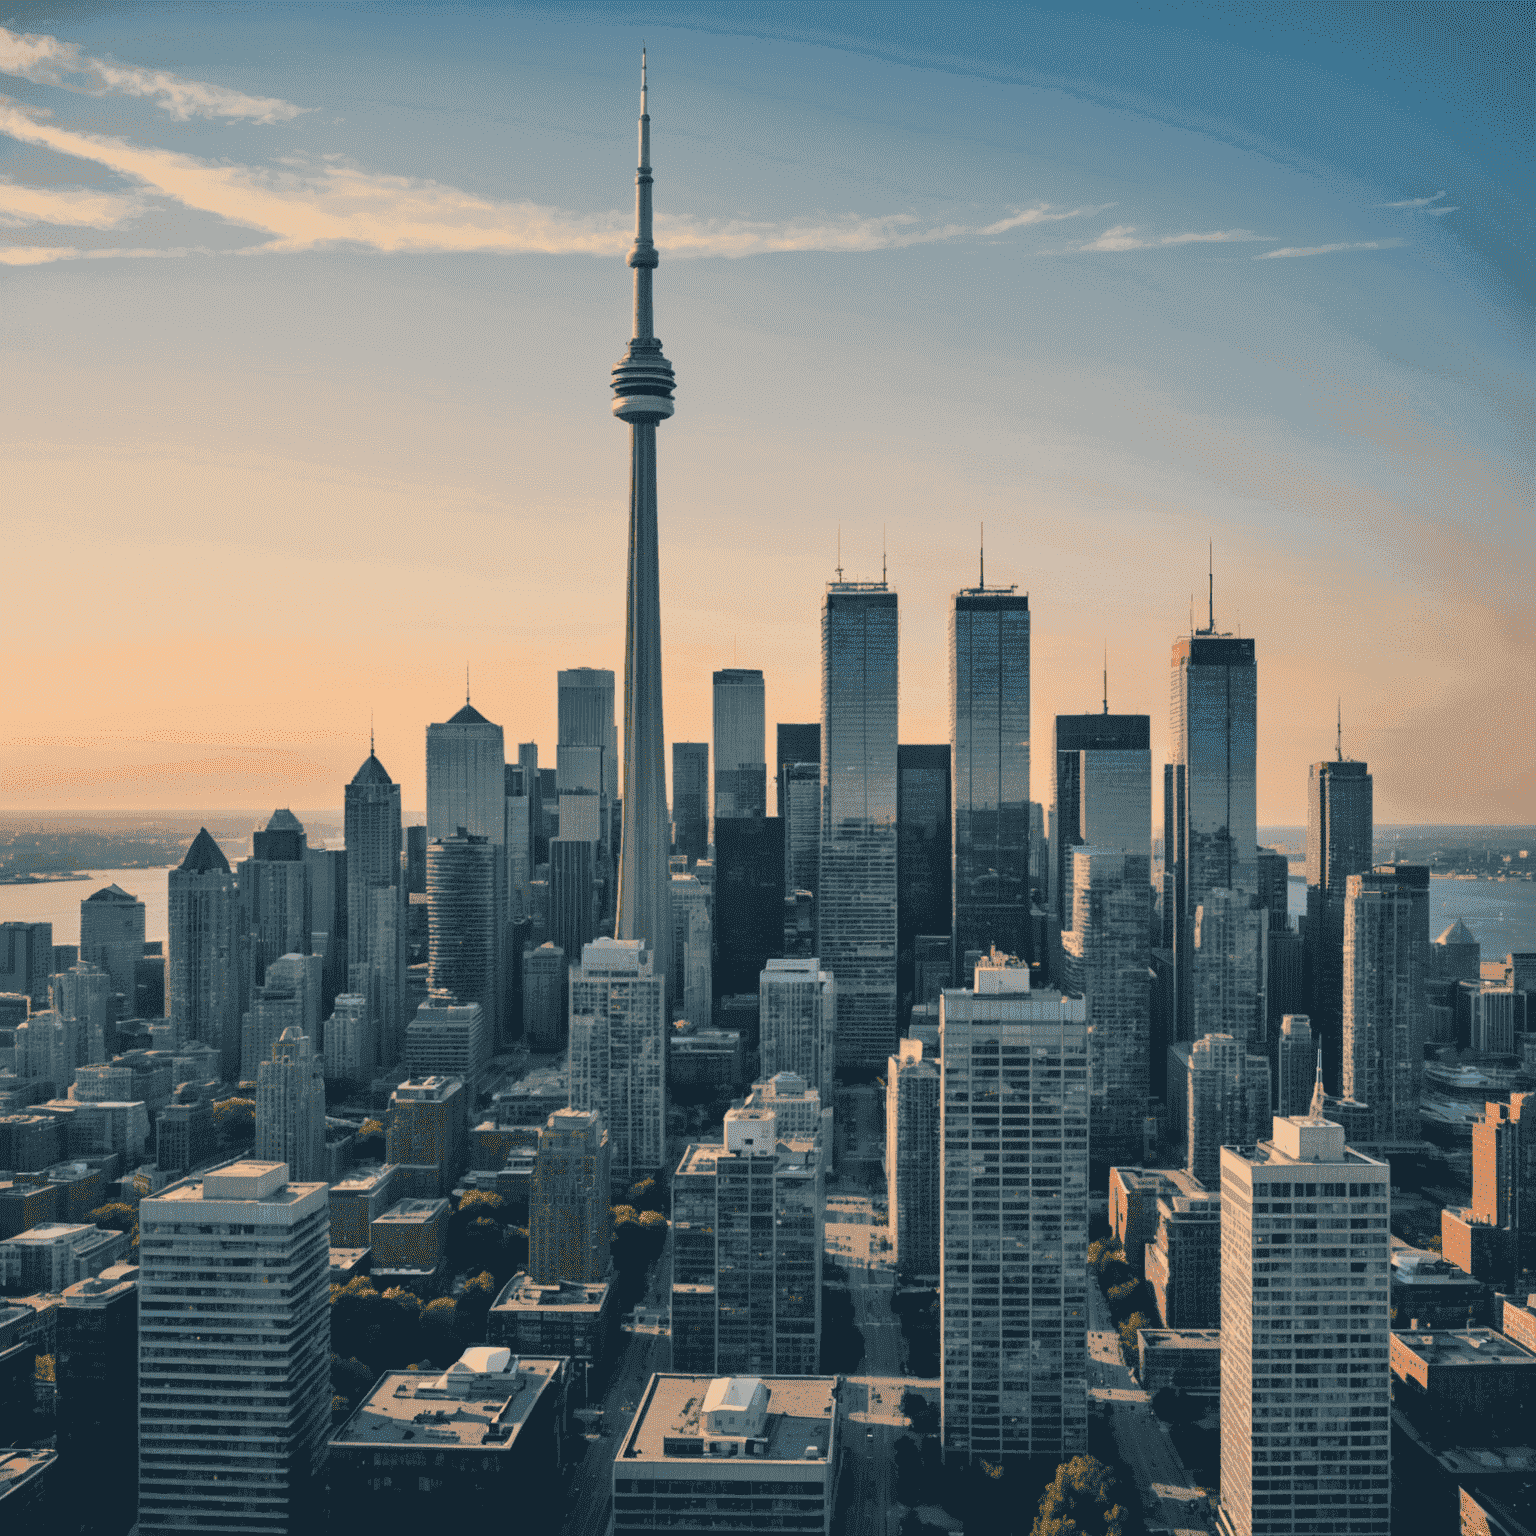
<box><xmin>613</xmin><ymin>51</ymin><xmax>673</xmax><ymax>975</ymax></box>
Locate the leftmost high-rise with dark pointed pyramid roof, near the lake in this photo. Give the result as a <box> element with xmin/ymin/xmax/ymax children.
<box><xmin>166</xmin><ymin>826</ymin><xmax>241</xmax><ymax>1078</ymax></box>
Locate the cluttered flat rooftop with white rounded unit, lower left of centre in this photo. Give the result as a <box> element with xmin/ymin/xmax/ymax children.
<box><xmin>330</xmin><ymin>1346</ymin><xmax>564</xmax><ymax>1453</ymax></box>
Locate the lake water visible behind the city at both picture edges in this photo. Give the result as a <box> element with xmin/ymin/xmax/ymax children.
<box><xmin>0</xmin><ymin>868</ymin><xmax>1536</xmax><ymax>960</ymax></box>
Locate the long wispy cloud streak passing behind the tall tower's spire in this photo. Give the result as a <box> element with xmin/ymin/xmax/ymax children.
<box><xmin>0</xmin><ymin>97</ymin><xmax>1101</xmax><ymax>260</ymax></box>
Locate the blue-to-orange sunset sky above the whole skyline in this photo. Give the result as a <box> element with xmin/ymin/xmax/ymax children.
<box><xmin>0</xmin><ymin>0</ymin><xmax>1536</xmax><ymax>823</ymax></box>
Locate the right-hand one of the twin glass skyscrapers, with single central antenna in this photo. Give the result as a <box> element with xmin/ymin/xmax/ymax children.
<box><xmin>949</xmin><ymin>587</ymin><xmax>1034</xmax><ymax>985</ymax></box>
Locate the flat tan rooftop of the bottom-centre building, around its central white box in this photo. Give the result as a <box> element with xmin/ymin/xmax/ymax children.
<box><xmin>617</xmin><ymin>1373</ymin><xmax>837</xmax><ymax>1462</ymax></box>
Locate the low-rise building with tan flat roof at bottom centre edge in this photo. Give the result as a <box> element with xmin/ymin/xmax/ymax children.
<box><xmin>611</xmin><ymin>1373</ymin><xmax>842</xmax><ymax>1536</ymax></box>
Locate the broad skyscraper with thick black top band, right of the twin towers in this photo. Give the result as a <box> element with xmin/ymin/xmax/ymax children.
<box><xmin>1051</xmin><ymin>712</ymin><xmax>1152</xmax><ymax>928</ymax></box>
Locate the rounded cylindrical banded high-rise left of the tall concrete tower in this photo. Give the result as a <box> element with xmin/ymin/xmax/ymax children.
<box><xmin>427</xmin><ymin>829</ymin><xmax>505</xmax><ymax>1044</ymax></box>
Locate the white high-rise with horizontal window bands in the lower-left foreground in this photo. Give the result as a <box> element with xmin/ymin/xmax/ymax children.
<box><xmin>138</xmin><ymin>1161</ymin><xmax>330</xmax><ymax>1536</ymax></box>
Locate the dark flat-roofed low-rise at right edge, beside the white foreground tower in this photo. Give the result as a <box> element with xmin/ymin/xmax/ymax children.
<box><xmin>1390</xmin><ymin>1329</ymin><xmax>1536</xmax><ymax>1445</ymax></box>
